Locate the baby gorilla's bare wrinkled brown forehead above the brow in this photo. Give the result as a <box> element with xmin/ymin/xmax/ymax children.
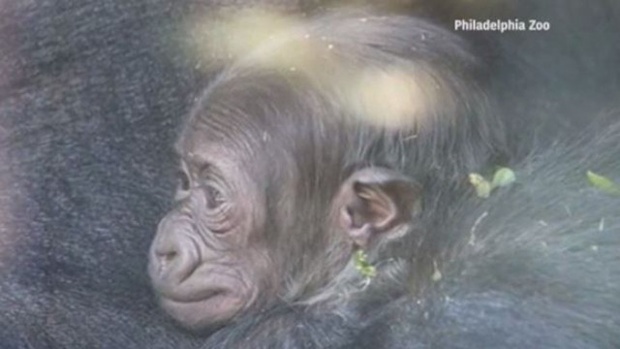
<box><xmin>177</xmin><ymin>73</ymin><xmax>314</xmax><ymax>155</ymax></box>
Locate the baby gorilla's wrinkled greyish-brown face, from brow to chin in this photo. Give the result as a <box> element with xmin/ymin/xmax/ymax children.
<box><xmin>149</xmin><ymin>130</ymin><xmax>270</xmax><ymax>329</ymax></box>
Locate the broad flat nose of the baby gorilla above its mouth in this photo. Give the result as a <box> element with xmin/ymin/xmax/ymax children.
<box><xmin>149</xmin><ymin>217</ymin><xmax>200</xmax><ymax>294</ymax></box>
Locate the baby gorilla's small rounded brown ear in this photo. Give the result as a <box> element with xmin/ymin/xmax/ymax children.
<box><xmin>335</xmin><ymin>167</ymin><xmax>421</xmax><ymax>248</ymax></box>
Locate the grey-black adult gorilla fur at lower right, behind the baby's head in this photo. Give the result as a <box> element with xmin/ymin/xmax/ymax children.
<box><xmin>351</xmin><ymin>122</ymin><xmax>620</xmax><ymax>348</ymax></box>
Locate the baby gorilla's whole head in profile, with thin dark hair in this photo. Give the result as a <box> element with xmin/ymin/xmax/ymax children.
<box><xmin>149</xmin><ymin>13</ymin><xmax>503</xmax><ymax>340</ymax></box>
